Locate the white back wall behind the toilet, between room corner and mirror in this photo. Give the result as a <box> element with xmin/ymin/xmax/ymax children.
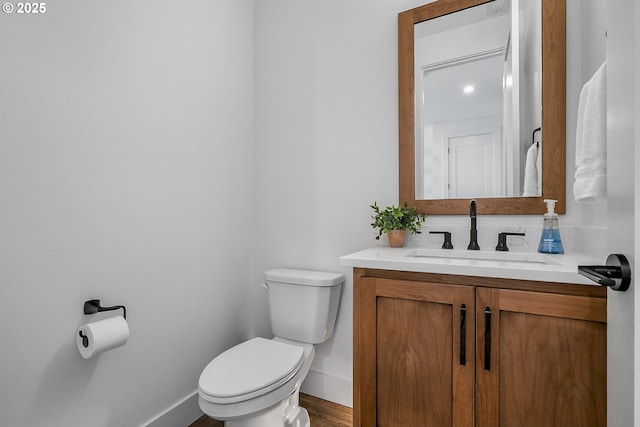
<box><xmin>254</xmin><ymin>0</ymin><xmax>432</xmax><ymax>404</ymax></box>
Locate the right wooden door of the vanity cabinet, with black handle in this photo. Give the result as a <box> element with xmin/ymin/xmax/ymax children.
<box><xmin>476</xmin><ymin>288</ymin><xmax>607</xmax><ymax>427</ymax></box>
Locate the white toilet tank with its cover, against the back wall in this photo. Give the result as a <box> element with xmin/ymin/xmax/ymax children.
<box><xmin>264</xmin><ymin>268</ymin><xmax>344</xmax><ymax>344</ymax></box>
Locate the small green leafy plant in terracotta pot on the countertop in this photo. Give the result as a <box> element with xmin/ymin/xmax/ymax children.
<box><xmin>370</xmin><ymin>202</ymin><xmax>427</xmax><ymax>247</ymax></box>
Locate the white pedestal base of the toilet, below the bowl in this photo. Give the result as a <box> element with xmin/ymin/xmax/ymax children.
<box><xmin>224</xmin><ymin>391</ymin><xmax>311</xmax><ymax>427</ymax></box>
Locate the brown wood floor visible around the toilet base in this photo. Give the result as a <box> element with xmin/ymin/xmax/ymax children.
<box><xmin>189</xmin><ymin>393</ymin><xmax>353</xmax><ymax>427</ymax></box>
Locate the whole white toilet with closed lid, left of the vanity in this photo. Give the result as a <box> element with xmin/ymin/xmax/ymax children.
<box><xmin>198</xmin><ymin>269</ymin><xmax>344</xmax><ymax>427</ymax></box>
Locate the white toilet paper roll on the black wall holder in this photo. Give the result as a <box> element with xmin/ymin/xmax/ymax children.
<box><xmin>76</xmin><ymin>316</ymin><xmax>129</xmax><ymax>359</ymax></box>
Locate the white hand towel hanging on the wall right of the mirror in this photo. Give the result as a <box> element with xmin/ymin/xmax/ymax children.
<box><xmin>573</xmin><ymin>62</ymin><xmax>607</xmax><ymax>202</ymax></box>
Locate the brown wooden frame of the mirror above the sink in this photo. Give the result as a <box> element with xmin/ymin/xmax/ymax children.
<box><xmin>398</xmin><ymin>0</ymin><xmax>567</xmax><ymax>215</ymax></box>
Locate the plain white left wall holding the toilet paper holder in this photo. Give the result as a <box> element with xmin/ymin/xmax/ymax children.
<box><xmin>0</xmin><ymin>0</ymin><xmax>253</xmax><ymax>427</ymax></box>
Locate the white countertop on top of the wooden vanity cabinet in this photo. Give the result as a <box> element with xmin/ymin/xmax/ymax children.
<box><xmin>340</xmin><ymin>246</ymin><xmax>602</xmax><ymax>286</ymax></box>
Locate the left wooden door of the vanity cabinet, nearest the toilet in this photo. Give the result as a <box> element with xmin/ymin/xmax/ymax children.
<box><xmin>354</xmin><ymin>278</ymin><xmax>475</xmax><ymax>427</ymax></box>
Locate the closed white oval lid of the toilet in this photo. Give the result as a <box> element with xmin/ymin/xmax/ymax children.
<box><xmin>198</xmin><ymin>338</ymin><xmax>304</xmax><ymax>403</ymax></box>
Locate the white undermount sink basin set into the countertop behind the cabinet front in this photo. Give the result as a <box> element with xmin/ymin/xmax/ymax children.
<box><xmin>405</xmin><ymin>249</ymin><xmax>561</xmax><ymax>265</ymax></box>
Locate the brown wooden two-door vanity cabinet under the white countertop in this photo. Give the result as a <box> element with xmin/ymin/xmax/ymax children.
<box><xmin>353</xmin><ymin>268</ymin><xmax>606</xmax><ymax>427</ymax></box>
